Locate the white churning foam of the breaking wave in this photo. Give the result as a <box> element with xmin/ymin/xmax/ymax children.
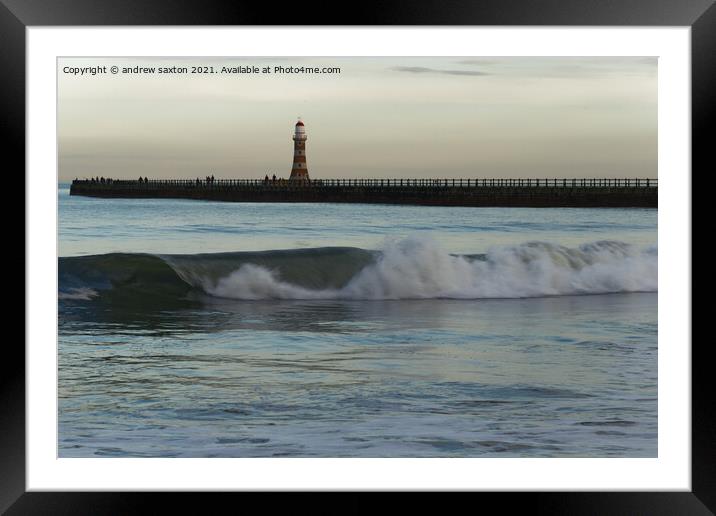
<box><xmin>202</xmin><ymin>238</ymin><xmax>658</xmax><ymax>299</ymax></box>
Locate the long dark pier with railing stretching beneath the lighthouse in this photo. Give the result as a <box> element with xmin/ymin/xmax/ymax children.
<box><xmin>70</xmin><ymin>179</ymin><xmax>658</xmax><ymax>208</ymax></box>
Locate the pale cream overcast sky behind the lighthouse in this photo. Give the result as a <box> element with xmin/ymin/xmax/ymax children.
<box><xmin>58</xmin><ymin>57</ymin><xmax>657</xmax><ymax>181</ymax></box>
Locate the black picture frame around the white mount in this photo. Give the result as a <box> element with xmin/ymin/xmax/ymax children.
<box><xmin>5</xmin><ymin>0</ymin><xmax>716</xmax><ymax>514</ymax></box>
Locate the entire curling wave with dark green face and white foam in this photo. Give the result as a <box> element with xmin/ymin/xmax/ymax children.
<box><xmin>59</xmin><ymin>237</ymin><xmax>658</xmax><ymax>302</ymax></box>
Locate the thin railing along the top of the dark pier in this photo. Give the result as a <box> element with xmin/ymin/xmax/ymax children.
<box><xmin>73</xmin><ymin>178</ymin><xmax>658</xmax><ymax>189</ymax></box>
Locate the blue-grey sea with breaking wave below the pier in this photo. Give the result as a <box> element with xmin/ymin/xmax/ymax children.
<box><xmin>58</xmin><ymin>184</ymin><xmax>658</xmax><ymax>457</ymax></box>
